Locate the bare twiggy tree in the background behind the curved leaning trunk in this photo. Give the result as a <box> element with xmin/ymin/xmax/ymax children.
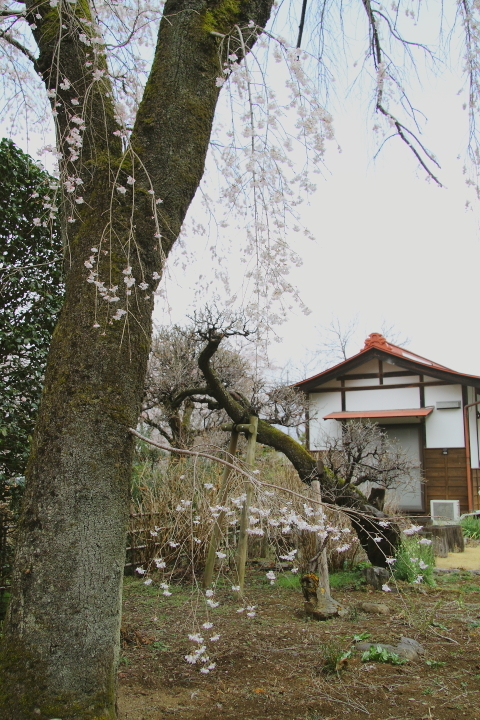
<box><xmin>140</xmin><ymin>320</ymin><xmax>306</xmax><ymax>450</ymax></box>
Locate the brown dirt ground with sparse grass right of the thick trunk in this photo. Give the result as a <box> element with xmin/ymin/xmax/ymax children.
<box><xmin>119</xmin><ymin>570</ymin><xmax>480</xmax><ymax>720</ymax></box>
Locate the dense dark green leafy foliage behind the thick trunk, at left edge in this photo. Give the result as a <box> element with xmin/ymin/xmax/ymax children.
<box><xmin>0</xmin><ymin>139</ymin><xmax>63</xmax><ymax>504</ymax></box>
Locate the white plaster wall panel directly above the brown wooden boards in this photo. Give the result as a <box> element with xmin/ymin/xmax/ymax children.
<box><xmin>425</xmin><ymin>385</ymin><xmax>465</xmax><ymax>448</ymax></box>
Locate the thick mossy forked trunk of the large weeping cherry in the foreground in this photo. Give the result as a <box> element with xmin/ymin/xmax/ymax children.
<box><xmin>0</xmin><ymin>0</ymin><xmax>272</xmax><ymax>720</ymax></box>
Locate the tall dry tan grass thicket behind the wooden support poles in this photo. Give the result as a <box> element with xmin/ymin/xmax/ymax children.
<box><xmin>127</xmin><ymin>448</ymin><xmax>360</xmax><ymax>579</ymax></box>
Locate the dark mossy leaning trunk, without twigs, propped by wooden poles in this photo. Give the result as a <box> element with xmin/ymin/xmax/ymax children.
<box><xmin>198</xmin><ymin>328</ymin><xmax>399</xmax><ymax>567</ymax></box>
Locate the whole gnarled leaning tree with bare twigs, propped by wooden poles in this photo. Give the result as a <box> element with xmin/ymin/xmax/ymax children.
<box><xmin>197</xmin><ymin>315</ymin><xmax>402</xmax><ymax>567</ymax></box>
